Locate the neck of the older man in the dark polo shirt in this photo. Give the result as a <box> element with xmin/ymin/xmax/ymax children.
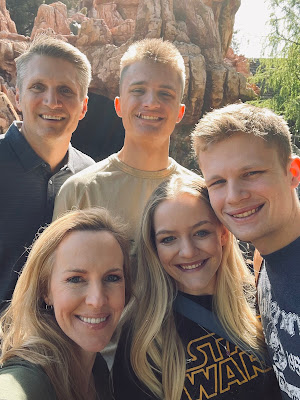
<box><xmin>21</xmin><ymin>124</ymin><xmax>71</xmax><ymax>172</ymax></box>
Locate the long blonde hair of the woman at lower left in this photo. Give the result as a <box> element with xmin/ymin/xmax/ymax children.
<box><xmin>0</xmin><ymin>208</ymin><xmax>131</xmax><ymax>400</ymax></box>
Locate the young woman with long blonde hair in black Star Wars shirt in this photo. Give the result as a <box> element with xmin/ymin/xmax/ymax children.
<box><xmin>113</xmin><ymin>177</ymin><xmax>281</xmax><ymax>400</ymax></box>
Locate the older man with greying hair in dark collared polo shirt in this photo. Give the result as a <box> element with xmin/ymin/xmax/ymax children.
<box><xmin>0</xmin><ymin>36</ymin><xmax>94</xmax><ymax>303</ymax></box>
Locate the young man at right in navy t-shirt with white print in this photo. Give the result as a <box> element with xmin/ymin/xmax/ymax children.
<box><xmin>192</xmin><ymin>104</ymin><xmax>300</xmax><ymax>400</ymax></box>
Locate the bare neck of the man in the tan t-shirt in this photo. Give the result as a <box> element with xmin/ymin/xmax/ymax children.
<box><xmin>118</xmin><ymin>140</ymin><xmax>169</xmax><ymax>171</ymax></box>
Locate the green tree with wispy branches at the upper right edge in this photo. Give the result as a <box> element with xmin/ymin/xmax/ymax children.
<box><xmin>254</xmin><ymin>0</ymin><xmax>300</xmax><ymax>135</ymax></box>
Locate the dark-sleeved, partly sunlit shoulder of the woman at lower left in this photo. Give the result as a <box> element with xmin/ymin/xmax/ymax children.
<box><xmin>0</xmin><ymin>359</ymin><xmax>56</xmax><ymax>400</ymax></box>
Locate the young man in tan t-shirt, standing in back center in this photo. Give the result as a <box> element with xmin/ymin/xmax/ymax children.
<box><xmin>54</xmin><ymin>39</ymin><xmax>195</xmax><ymax>248</ymax></box>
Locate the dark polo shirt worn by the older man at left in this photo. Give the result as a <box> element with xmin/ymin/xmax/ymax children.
<box><xmin>0</xmin><ymin>123</ymin><xmax>94</xmax><ymax>307</ymax></box>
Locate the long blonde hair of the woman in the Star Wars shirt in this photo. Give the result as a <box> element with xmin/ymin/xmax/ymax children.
<box><xmin>130</xmin><ymin>176</ymin><xmax>264</xmax><ymax>400</ymax></box>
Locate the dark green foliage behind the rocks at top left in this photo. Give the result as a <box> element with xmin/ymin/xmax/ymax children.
<box><xmin>6</xmin><ymin>0</ymin><xmax>79</xmax><ymax>36</ymax></box>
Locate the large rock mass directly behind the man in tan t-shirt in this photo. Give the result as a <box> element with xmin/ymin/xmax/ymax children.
<box><xmin>76</xmin><ymin>0</ymin><xmax>250</xmax><ymax>124</ymax></box>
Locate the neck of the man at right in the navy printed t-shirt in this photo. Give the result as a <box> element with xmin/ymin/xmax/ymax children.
<box><xmin>253</xmin><ymin>198</ymin><xmax>300</xmax><ymax>255</ymax></box>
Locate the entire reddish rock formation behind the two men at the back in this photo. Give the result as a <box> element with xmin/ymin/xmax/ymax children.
<box><xmin>0</xmin><ymin>0</ymin><xmax>255</xmax><ymax>166</ymax></box>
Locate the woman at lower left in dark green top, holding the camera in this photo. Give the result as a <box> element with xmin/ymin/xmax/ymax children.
<box><xmin>0</xmin><ymin>208</ymin><xmax>131</xmax><ymax>400</ymax></box>
